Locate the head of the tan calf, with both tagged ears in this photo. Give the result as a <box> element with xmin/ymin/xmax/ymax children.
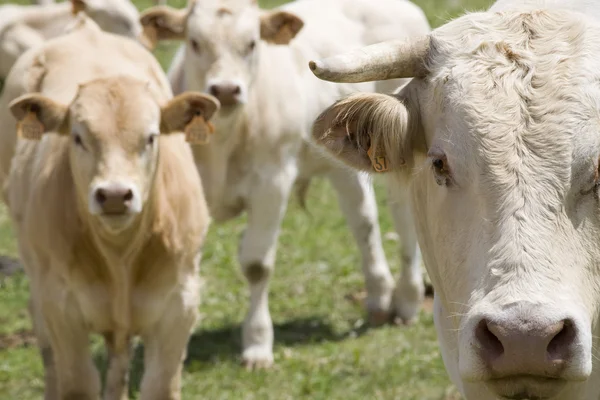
<box><xmin>10</xmin><ymin>76</ymin><xmax>219</xmax><ymax>233</ymax></box>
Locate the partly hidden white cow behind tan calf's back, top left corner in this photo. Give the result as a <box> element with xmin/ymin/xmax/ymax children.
<box><xmin>0</xmin><ymin>0</ymin><xmax>142</xmax><ymax>79</ymax></box>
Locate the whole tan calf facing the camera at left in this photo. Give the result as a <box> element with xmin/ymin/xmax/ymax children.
<box><xmin>0</xmin><ymin>15</ymin><xmax>219</xmax><ymax>400</ymax></box>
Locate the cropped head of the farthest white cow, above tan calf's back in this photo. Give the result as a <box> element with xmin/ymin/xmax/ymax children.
<box><xmin>71</xmin><ymin>0</ymin><xmax>142</xmax><ymax>39</ymax></box>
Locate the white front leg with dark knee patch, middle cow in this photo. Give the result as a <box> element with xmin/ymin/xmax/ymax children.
<box><xmin>239</xmin><ymin>163</ymin><xmax>297</xmax><ymax>369</ymax></box>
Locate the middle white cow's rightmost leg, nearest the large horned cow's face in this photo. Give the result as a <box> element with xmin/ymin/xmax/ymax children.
<box><xmin>388</xmin><ymin>180</ymin><xmax>425</xmax><ymax>323</ymax></box>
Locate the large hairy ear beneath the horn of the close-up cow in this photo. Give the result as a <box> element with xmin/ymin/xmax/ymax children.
<box><xmin>312</xmin><ymin>93</ymin><xmax>416</xmax><ymax>172</ymax></box>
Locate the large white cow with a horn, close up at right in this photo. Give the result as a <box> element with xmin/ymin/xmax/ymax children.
<box><xmin>310</xmin><ymin>0</ymin><xmax>600</xmax><ymax>400</ymax></box>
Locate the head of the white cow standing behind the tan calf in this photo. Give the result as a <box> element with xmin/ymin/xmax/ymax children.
<box><xmin>141</xmin><ymin>0</ymin><xmax>303</xmax><ymax>107</ymax></box>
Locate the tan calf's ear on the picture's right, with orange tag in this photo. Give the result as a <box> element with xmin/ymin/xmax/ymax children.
<box><xmin>161</xmin><ymin>92</ymin><xmax>221</xmax><ymax>144</ymax></box>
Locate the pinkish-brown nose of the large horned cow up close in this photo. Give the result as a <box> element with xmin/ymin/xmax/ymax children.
<box><xmin>475</xmin><ymin>318</ymin><xmax>577</xmax><ymax>378</ymax></box>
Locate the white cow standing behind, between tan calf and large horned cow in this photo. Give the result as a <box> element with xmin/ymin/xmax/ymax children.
<box><xmin>141</xmin><ymin>0</ymin><xmax>429</xmax><ymax>367</ymax></box>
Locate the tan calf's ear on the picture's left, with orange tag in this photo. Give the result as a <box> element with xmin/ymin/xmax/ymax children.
<box><xmin>8</xmin><ymin>94</ymin><xmax>69</xmax><ymax>140</ymax></box>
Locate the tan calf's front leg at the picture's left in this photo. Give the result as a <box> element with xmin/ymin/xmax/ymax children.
<box><xmin>43</xmin><ymin>299</ymin><xmax>100</xmax><ymax>400</ymax></box>
